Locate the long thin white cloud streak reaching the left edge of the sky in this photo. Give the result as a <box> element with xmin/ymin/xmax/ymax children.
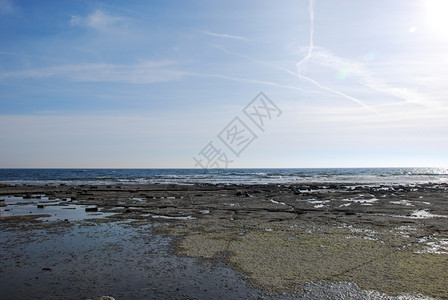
<box><xmin>0</xmin><ymin>61</ymin><xmax>183</xmax><ymax>84</ymax></box>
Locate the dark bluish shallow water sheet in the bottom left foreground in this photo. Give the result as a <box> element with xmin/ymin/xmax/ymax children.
<box><xmin>0</xmin><ymin>221</ymin><xmax>270</xmax><ymax>299</ymax></box>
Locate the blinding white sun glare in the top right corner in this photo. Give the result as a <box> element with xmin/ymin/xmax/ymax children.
<box><xmin>423</xmin><ymin>0</ymin><xmax>448</xmax><ymax>38</ymax></box>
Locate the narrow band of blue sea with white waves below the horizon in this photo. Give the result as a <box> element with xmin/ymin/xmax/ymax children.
<box><xmin>0</xmin><ymin>168</ymin><xmax>448</xmax><ymax>185</ymax></box>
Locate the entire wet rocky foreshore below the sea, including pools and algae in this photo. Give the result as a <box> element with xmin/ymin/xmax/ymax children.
<box><xmin>0</xmin><ymin>184</ymin><xmax>448</xmax><ymax>299</ymax></box>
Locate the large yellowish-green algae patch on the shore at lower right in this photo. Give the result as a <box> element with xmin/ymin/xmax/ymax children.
<box><xmin>163</xmin><ymin>221</ymin><xmax>448</xmax><ymax>298</ymax></box>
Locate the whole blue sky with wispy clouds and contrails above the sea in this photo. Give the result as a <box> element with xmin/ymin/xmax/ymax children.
<box><xmin>0</xmin><ymin>0</ymin><xmax>448</xmax><ymax>168</ymax></box>
